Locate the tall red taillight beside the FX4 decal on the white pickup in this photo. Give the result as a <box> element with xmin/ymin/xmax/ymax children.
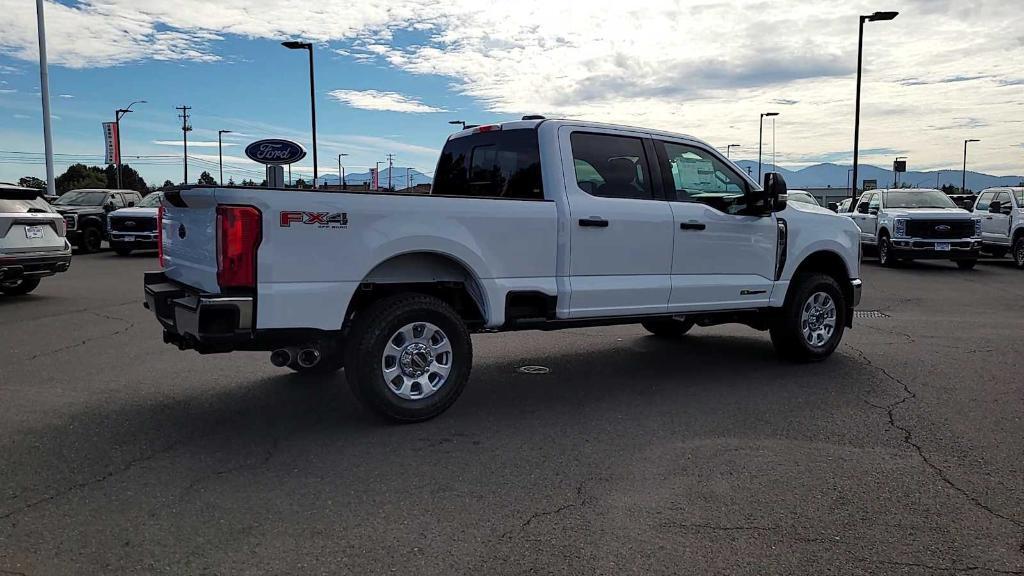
<box><xmin>217</xmin><ymin>206</ymin><xmax>263</xmax><ymax>290</ymax></box>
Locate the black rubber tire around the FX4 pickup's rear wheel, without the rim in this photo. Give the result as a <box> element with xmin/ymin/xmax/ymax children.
<box><xmin>345</xmin><ymin>293</ymin><xmax>473</xmax><ymax>422</ymax></box>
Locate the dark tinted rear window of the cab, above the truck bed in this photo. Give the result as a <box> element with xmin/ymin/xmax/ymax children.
<box><xmin>430</xmin><ymin>129</ymin><xmax>544</xmax><ymax>200</ymax></box>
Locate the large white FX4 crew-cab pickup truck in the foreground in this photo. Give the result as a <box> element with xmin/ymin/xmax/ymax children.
<box><xmin>145</xmin><ymin>119</ymin><xmax>861</xmax><ymax>421</ymax></box>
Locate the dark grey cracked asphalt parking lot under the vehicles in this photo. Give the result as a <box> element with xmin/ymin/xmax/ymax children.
<box><xmin>0</xmin><ymin>252</ymin><xmax>1024</xmax><ymax>575</ymax></box>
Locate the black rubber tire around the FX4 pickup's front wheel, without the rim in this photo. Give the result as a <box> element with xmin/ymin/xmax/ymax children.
<box><xmin>770</xmin><ymin>274</ymin><xmax>847</xmax><ymax>362</ymax></box>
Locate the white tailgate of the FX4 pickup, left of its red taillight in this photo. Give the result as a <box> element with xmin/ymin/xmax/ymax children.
<box><xmin>160</xmin><ymin>189</ymin><xmax>219</xmax><ymax>292</ymax></box>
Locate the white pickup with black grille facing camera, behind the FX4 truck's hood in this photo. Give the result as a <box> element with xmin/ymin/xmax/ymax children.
<box><xmin>850</xmin><ymin>189</ymin><xmax>981</xmax><ymax>270</ymax></box>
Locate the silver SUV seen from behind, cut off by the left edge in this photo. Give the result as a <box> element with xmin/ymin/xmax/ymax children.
<box><xmin>0</xmin><ymin>182</ymin><xmax>71</xmax><ymax>295</ymax></box>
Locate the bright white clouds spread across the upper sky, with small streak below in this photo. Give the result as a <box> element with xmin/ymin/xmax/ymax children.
<box><xmin>0</xmin><ymin>0</ymin><xmax>1024</xmax><ymax>172</ymax></box>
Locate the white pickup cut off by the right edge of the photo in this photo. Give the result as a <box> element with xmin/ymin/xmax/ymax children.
<box><xmin>974</xmin><ymin>188</ymin><xmax>1024</xmax><ymax>269</ymax></box>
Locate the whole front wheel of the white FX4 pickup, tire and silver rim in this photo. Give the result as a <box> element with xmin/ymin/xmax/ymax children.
<box><xmin>770</xmin><ymin>274</ymin><xmax>847</xmax><ymax>362</ymax></box>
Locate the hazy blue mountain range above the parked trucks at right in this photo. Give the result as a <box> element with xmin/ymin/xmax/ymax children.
<box><xmin>736</xmin><ymin>160</ymin><xmax>1024</xmax><ymax>192</ymax></box>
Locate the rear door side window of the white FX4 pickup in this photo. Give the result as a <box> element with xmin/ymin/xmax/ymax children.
<box><xmin>570</xmin><ymin>132</ymin><xmax>652</xmax><ymax>200</ymax></box>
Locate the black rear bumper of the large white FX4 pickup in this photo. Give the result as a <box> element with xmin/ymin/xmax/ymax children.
<box><xmin>143</xmin><ymin>272</ymin><xmax>255</xmax><ymax>353</ymax></box>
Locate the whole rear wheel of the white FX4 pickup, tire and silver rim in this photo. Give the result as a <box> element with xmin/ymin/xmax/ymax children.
<box><xmin>345</xmin><ymin>293</ymin><xmax>473</xmax><ymax>422</ymax></box>
